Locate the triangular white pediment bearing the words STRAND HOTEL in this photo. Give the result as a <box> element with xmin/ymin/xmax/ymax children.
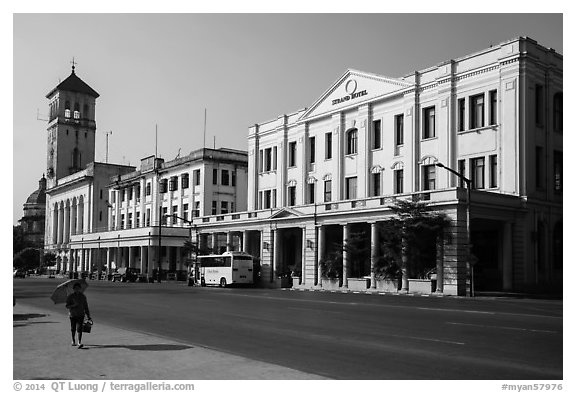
<box><xmin>300</xmin><ymin>70</ymin><xmax>413</xmax><ymax>120</ymax></box>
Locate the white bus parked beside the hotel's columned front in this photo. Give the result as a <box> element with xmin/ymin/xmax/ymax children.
<box><xmin>198</xmin><ymin>251</ymin><xmax>254</xmax><ymax>287</ymax></box>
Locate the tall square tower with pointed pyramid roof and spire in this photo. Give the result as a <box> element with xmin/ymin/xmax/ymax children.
<box><xmin>46</xmin><ymin>60</ymin><xmax>100</xmax><ymax>189</ymax></box>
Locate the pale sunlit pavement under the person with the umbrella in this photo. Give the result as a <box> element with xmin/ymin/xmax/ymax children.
<box><xmin>13</xmin><ymin>303</ymin><xmax>323</xmax><ymax>380</ymax></box>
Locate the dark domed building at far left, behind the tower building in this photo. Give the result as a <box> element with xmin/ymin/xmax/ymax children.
<box><xmin>18</xmin><ymin>176</ymin><xmax>46</xmax><ymax>248</ymax></box>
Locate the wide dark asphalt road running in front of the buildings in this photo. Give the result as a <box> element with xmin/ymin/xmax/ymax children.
<box><xmin>14</xmin><ymin>278</ymin><xmax>563</xmax><ymax>380</ymax></box>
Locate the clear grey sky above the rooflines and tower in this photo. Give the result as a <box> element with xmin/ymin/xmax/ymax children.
<box><xmin>12</xmin><ymin>13</ymin><xmax>563</xmax><ymax>224</ymax></box>
